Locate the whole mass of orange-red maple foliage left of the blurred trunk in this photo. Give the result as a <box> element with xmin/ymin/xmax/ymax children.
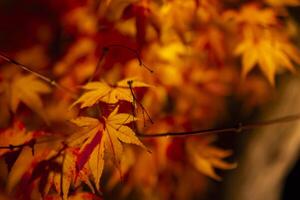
<box><xmin>0</xmin><ymin>0</ymin><xmax>300</xmax><ymax>199</ymax></box>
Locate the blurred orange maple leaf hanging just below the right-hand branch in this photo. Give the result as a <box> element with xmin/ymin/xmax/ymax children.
<box><xmin>186</xmin><ymin>136</ymin><xmax>237</xmax><ymax>180</ymax></box>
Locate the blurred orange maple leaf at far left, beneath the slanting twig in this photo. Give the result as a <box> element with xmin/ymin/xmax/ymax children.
<box><xmin>10</xmin><ymin>75</ymin><xmax>51</xmax><ymax>116</ymax></box>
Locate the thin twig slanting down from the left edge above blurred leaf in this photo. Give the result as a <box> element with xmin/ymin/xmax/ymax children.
<box><xmin>0</xmin><ymin>52</ymin><xmax>74</xmax><ymax>95</ymax></box>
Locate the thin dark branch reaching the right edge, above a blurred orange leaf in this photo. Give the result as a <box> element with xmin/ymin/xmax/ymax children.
<box><xmin>137</xmin><ymin>114</ymin><xmax>300</xmax><ymax>138</ymax></box>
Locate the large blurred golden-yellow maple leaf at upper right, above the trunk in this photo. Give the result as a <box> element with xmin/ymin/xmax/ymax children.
<box><xmin>235</xmin><ymin>30</ymin><xmax>300</xmax><ymax>85</ymax></box>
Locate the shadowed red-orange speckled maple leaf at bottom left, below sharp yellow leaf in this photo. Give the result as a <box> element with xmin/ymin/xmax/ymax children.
<box><xmin>19</xmin><ymin>145</ymin><xmax>94</xmax><ymax>200</ymax></box>
